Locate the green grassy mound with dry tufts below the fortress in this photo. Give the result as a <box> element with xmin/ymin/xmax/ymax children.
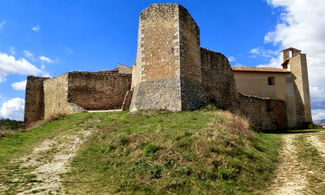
<box><xmin>0</xmin><ymin>110</ymin><xmax>280</xmax><ymax>194</ymax></box>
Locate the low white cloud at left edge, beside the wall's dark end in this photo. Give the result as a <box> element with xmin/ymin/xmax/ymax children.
<box><xmin>0</xmin><ymin>98</ymin><xmax>25</xmax><ymax>120</ymax></box>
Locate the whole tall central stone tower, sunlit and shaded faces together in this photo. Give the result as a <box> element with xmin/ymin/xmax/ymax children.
<box><xmin>130</xmin><ymin>4</ymin><xmax>205</xmax><ymax>112</ymax></box>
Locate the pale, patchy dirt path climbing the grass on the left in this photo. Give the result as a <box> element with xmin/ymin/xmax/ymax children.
<box><xmin>1</xmin><ymin>130</ymin><xmax>91</xmax><ymax>194</ymax></box>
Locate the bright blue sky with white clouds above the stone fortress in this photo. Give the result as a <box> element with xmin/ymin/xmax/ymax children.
<box><xmin>0</xmin><ymin>0</ymin><xmax>325</xmax><ymax>119</ymax></box>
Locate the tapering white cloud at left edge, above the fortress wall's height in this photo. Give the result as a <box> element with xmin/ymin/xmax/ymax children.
<box><xmin>0</xmin><ymin>52</ymin><xmax>41</xmax><ymax>82</ymax></box>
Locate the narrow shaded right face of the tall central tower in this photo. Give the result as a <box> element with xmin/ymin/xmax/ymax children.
<box><xmin>179</xmin><ymin>6</ymin><xmax>206</xmax><ymax>110</ymax></box>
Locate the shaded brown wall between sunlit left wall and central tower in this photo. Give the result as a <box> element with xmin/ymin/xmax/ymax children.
<box><xmin>67</xmin><ymin>72</ymin><xmax>132</xmax><ymax>110</ymax></box>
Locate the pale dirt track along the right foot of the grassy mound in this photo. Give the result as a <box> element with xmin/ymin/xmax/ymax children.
<box><xmin>265</xmin><ymin>134</ymin><xmax>308</xmax><ymax>195</ymax></box>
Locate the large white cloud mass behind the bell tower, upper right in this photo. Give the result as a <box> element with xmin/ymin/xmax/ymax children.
<box><xmin>264</xmin><ymin>0</ymin><xmax>325</xmax><ymax>119</ymax></box>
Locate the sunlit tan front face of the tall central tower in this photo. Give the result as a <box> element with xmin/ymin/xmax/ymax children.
<box><xmin>130</xmin><ymin>4</ymin><xmax>182</xmax><ymax>112</ymax></box>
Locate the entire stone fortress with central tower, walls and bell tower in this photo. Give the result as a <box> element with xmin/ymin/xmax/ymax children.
<box><xmin>25</xmin><ymin>4</ymin><xmax>312</xmax><ymax>130</ymax></box>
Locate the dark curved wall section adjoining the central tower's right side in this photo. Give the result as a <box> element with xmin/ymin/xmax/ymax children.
<box><xmin>200</xmin><ymin>48</ymin><xmax>238</xmax><ymax>108</ymax></box>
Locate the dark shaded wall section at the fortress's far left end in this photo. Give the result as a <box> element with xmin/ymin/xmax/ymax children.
<box><xmin>24</xmin><ymin>76</ymin><xmax>48</xmax><ymax>127</ymax></box>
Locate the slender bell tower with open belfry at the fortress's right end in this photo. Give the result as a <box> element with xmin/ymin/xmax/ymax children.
<box><xmin>281</xmin><ymin>48</ymin><xmax>312</xmax><ymax>127</ymax></box>
